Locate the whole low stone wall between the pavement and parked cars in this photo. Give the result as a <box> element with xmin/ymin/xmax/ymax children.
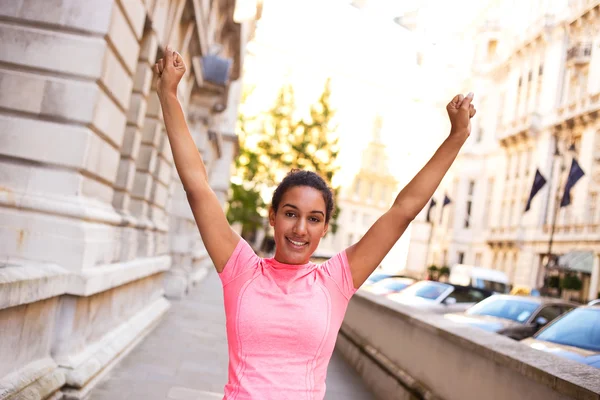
<box><xmin>336</xmin><ymin>291</ymin><xmax>600</xmax><ymax>400</ymax></box>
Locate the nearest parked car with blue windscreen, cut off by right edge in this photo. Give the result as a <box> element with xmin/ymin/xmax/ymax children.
<box><xmin>521</xmin><ymin>306</ymin><xmax>600</xmax><ymax>368</ymax></box>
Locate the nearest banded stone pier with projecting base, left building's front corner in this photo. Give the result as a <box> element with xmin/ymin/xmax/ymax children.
<box><xmin>0</xmin><ymin>0</ymin><xmax>170</xmax><ymax>398</ymax></box>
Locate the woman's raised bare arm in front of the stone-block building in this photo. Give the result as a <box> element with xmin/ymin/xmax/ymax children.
<box><xmin>154</xmin><ymin>46</ymin><xmax>240</xmax><ymax>272</ymax></box>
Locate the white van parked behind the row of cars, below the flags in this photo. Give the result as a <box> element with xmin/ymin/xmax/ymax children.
<box><xmin>448</xmin><ymin>264</ymin><xmax>510</xmax><ymax>294</ymax></box>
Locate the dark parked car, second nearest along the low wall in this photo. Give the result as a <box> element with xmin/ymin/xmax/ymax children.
<box><xmin>445</xmin><ymin>295</ymin><xmax>577</xmax><ymax>340</ymax></box>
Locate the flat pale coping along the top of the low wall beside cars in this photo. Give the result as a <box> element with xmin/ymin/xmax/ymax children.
<box><xmin>355</xmin><ymin>290</ymin><xmax>600</xmax><ymax>400</ymax></box>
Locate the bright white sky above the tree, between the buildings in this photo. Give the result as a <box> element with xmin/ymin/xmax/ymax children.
<box><xmin>242</xmin><ymin>0</ymin><xmax>492</xmax><ymax>189</ymax></box>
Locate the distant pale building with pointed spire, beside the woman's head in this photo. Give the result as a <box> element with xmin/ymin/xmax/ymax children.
<box><xmin>315</xmin><ymin>117</ymin><xmax>408</xmax><ymax>272</ymax></box>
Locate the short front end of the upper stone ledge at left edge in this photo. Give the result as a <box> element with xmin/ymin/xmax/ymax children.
<box><xmin>0</xmin><ymin>263</ymin><xmax>70</xmax><ymax>310</ymax></box>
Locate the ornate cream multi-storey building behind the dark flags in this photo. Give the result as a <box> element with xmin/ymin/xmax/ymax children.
<box><xmin>409</xmin><ymin>0</ymin><xmax>600</xmax><ymax>301</ymax></box>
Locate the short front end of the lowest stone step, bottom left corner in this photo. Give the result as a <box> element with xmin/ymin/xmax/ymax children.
<box><xmin>0</xmin><ymin>358</ymin><xmax>65</xmax><ymax>400</ymax></box>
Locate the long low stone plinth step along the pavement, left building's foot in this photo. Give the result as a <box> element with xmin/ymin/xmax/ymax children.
<box><xmin>57</xmin><ymin>298</ymin><xmax>171</xmax><ymax>390</ymax></box>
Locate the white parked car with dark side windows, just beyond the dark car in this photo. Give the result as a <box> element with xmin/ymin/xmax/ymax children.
<box><xmin>387</xmin><ymin>281</ymin><xmax>493</xmax><ymax>314</ymax></box>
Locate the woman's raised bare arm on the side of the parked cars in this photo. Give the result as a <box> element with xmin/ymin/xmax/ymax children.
<box><xmin>346</xmin><ymin>93</ymin><xmax>475</xmax><ymax>288</ymax></box>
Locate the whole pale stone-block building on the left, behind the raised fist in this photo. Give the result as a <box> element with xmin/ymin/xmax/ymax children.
<box><xmin>0</xmin><ymin>0</ymin><xmax>260</xmax><ymax>399</ymax></box>
